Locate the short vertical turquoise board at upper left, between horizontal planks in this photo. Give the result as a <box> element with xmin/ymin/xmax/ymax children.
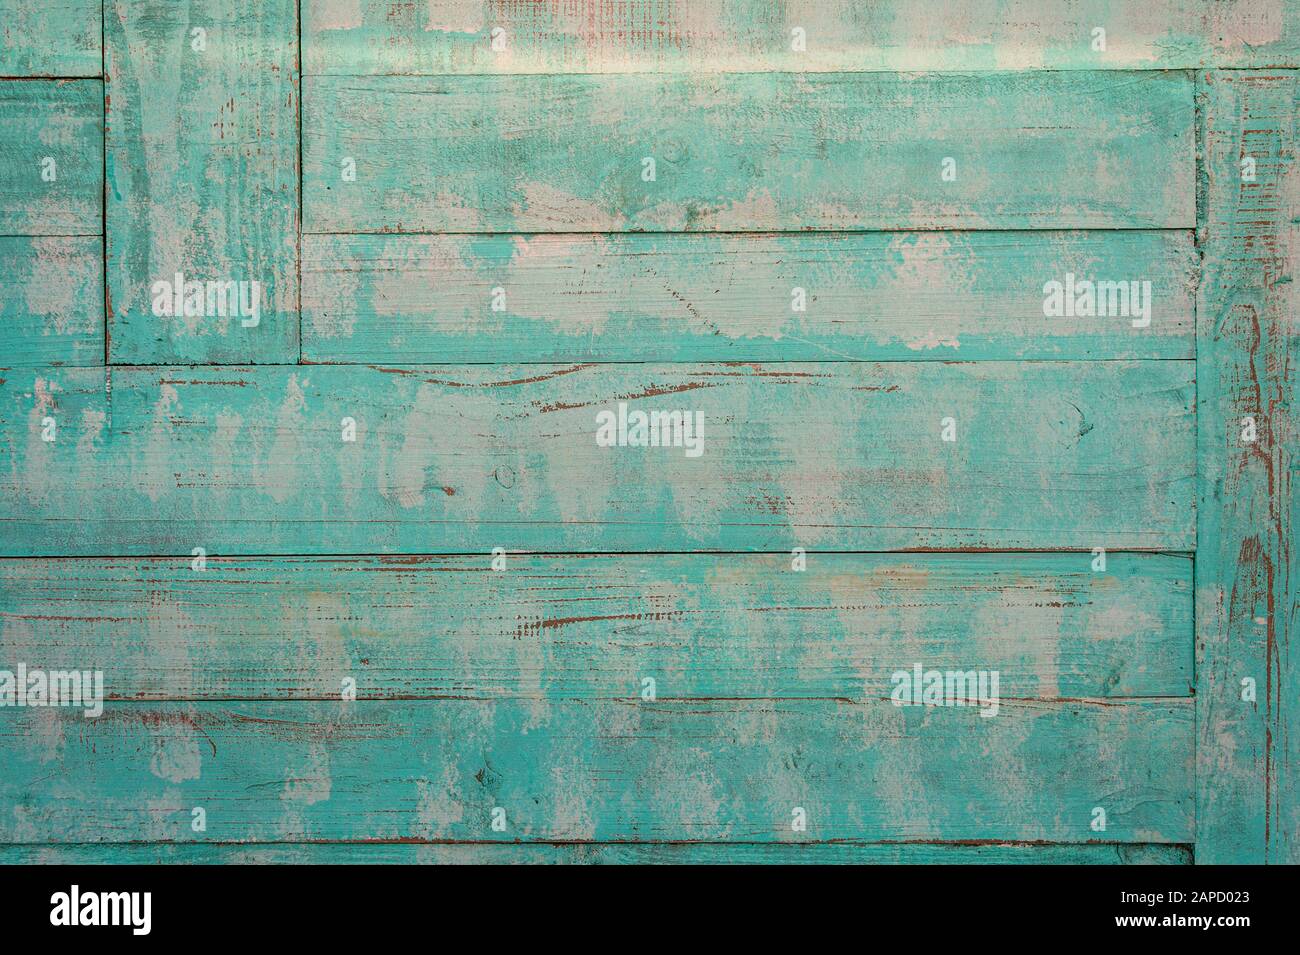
<box><xmin>105</xmin><ymin>0</ymin><xmax>299</xmax><ymax>364</ymax></box>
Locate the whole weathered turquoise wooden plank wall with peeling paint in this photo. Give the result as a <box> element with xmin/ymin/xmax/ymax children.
<box><xmin>0</xmin><ymin>0</ymin><xmax>1300</xmax><ymax>864</ymax></box>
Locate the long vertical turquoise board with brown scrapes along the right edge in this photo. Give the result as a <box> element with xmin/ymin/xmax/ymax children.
<box><xmin>1196</xmin><ymin>71</ymin><xmax>1300</xmax><ymax>864</ymax></box>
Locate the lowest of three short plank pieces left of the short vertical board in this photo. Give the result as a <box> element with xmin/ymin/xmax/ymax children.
<box><xmin>0</xmin><ymin>235</ymin><xmax>104</xmax><ymax>368</ymax></box>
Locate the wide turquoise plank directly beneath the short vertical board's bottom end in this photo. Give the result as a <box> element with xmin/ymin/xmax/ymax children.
<box><xmin>0</xmin><ymin>361</ymin><xmax>1195</xmax><ymax>556</ymax></box>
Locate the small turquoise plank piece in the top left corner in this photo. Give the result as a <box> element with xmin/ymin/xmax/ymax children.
<box><xmin>0</xmin><ymin>0</ymin><xmax>104</xmax><ymax>77</ymax></box>
